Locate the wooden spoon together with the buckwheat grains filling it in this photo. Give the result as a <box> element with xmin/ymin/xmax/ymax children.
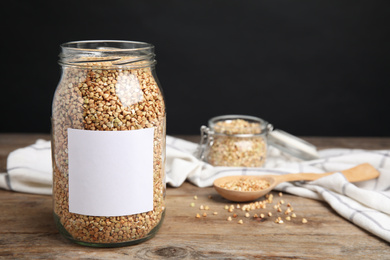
<box><xmin>214</xmin><ymin>163</ymin><xmax>379</xmax><ymax>202</ymax></box>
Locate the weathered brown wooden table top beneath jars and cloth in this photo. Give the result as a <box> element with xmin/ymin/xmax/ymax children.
<box><xmin>0</xmin><ymin>134</ymin><xmax>390</xmax><ymax>259</ymax></box>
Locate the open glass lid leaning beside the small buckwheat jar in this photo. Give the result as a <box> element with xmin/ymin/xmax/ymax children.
<box><xmin>268</xmin><ymin>129</ymin><xmax>319</xmax><ymax>160</ymax></box>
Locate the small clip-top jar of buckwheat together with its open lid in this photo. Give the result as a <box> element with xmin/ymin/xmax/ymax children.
<box><xmin>198</xmin><ymin>115</ymin><xmax>318</xmax><ymax>167</ymax></box>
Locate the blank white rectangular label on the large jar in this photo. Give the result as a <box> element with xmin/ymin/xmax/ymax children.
<box><xmin>68</xmin><ymin>128</ymin><xmax>154</xmax><ymax>217</ymax></box>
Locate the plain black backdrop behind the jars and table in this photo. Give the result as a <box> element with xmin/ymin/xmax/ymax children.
<box><xmin>0</xmin><ymin>0</ymin><xmax>390</xmax><ymax>136</ymax></box>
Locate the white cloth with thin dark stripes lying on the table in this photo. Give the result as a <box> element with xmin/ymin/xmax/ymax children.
<box><xmin>0</xmin><ymin>136</ymin><xmax>390</xmax><ymax>242</ymax></box>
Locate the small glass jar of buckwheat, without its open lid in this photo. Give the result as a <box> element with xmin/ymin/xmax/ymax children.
<box><xmin>199</xmin><ymin>115</ymin><xmax>272</xmax><ymax>167</ymax></box>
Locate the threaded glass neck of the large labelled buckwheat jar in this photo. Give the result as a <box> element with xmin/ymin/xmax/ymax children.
<box><xmin>59</xmin><ymin>41</ymin><xmax>156</xmax><ymax>68</ymax></box>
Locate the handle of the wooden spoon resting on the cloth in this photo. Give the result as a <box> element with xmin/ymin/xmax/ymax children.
<box><xmin>277</xmin><ymin>163</ymin><xmax>379</xmax><ymax>184</ymax></box>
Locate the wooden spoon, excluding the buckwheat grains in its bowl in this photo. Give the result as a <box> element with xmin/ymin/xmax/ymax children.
<box><xmin>214</xmin><ymin>163</ymin><xmax>379</xmax><ymax>202</ymax></box>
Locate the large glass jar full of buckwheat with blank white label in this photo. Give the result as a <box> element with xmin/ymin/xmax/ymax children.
<box><xmin>52</xmin><ymin>41</ymin><xmax>166</xmax><ymax>247</ymax></box>
